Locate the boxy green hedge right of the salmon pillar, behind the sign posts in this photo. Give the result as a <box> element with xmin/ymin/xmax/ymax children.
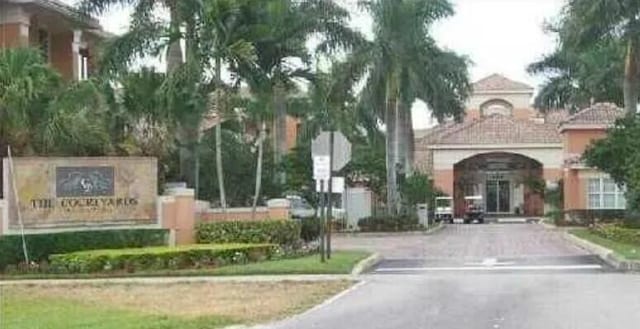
<box><xmin>196</xmin><ymin>220</ymin><xmax>301</xmax><ymax>246</ymax></box>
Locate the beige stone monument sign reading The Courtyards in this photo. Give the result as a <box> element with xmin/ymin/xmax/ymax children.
<box><xmin>3</xmin><ymin>157</ymin><xmax>158</xmax><ymax>232</ymax></box>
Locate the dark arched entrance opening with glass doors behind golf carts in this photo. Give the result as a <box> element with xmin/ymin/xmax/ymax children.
<box><xmin>453</xmin><ymin>152</ymin><xmax>545</xmax><ymax>217</ymax></box>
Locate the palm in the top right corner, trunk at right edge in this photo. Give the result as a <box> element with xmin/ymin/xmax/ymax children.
<box><xmin>561</xmin><ymin>0</ymin><xmax>640</xmax><ymax>114</ymax></box>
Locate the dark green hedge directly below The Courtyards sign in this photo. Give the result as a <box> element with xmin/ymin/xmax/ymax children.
<box><xmin>0</xmin><ymin>229</ymin><xmax>168</xmax><ymax>271</ymax></box>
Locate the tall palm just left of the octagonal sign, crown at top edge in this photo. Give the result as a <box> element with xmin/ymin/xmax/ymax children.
<box><xmin>235</xmin><ymin>0</ymin><xmax>362</xmax><ymax>182</ymax></box>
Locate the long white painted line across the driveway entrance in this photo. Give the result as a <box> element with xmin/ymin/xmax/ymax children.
<box><xmin>374</xmin><ymin>264</ymin><xmax>602</xmax><ymax>273</ymax></box>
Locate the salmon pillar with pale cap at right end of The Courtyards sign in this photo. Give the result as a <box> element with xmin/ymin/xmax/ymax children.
<box><xmin>162</xmin><ymin>188</ymin><xmax>196</xmax><ymax>245</ymax></box>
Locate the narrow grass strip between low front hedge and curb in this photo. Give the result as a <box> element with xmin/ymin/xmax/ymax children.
<box><xmin>0</xmin><ymin>251</ymin><xmax>370</xmax><ymax>280</ymax></box>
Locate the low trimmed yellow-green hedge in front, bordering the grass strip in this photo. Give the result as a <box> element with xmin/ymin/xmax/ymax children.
<box><xmin>49</xmin><ymin>244</ymin><xmax>278</xmax><ymax>273</ymax></box>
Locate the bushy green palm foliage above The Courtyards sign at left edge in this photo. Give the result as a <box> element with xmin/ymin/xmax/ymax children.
<box><xmin>0</xmin><ymin>48</ymin><xmax>111</xmax><ymax>155</ymax></box>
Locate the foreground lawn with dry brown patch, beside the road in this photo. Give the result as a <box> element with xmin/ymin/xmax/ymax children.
<box><xmin>0</xmin><ymin>281</ymin><xmax>351</xmax><ymax>329</ymax></box>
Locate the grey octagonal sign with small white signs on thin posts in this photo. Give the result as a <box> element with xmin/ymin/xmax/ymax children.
<box><xmin>311</xmin><ymin>131</ymin><xmax>351</xmax><ymax>259</ymax></box>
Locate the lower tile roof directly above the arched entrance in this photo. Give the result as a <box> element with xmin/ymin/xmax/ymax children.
<box><xmin>435</xmin><ymin>114</ymin><xmax>561</xmax><ymax>145</ymax></box>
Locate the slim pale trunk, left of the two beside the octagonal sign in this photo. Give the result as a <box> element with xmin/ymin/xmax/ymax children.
<box><xmin>385</xmin><ymin>83</ymin><xmax>399</xmax><ymax>215</ymax></box>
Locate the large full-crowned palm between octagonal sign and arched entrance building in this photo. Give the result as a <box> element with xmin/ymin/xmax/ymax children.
<box><xmin>347</xmin><ymin>0</ymin><xmax>470</xmax><ymax>214</ymax></box>
